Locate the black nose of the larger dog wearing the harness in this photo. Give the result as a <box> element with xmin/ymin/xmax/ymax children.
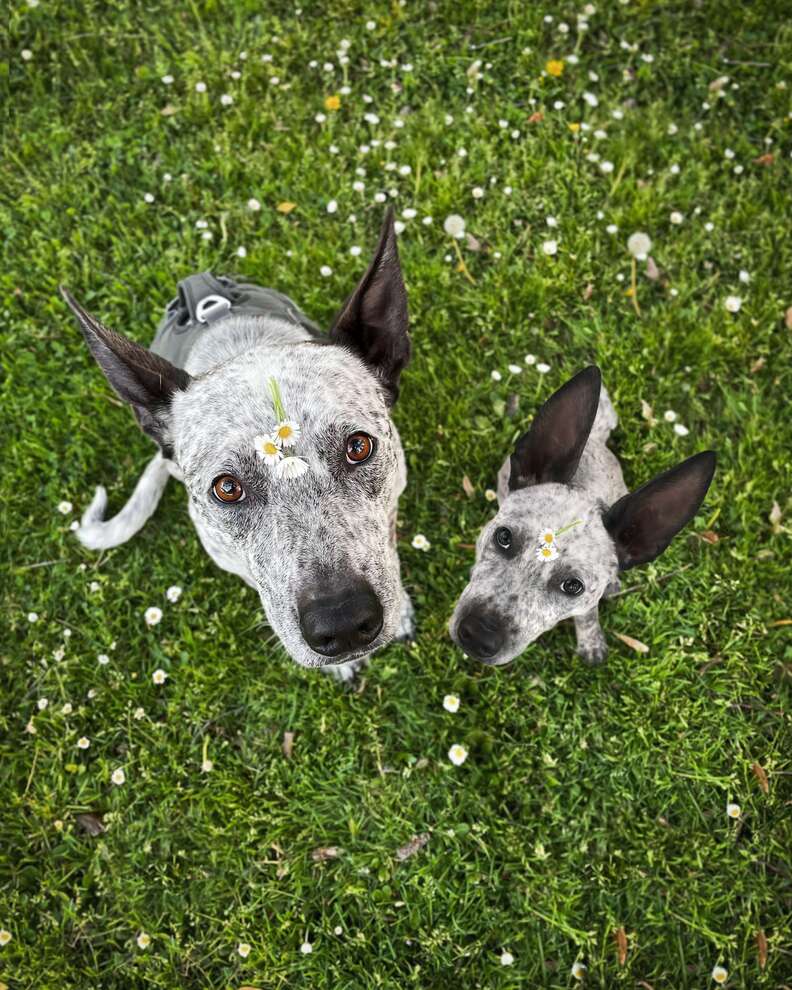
<box><xmin>299</xmin><ymin>581</ymin><xmax>382</xmax><ymax>658</ymax></box>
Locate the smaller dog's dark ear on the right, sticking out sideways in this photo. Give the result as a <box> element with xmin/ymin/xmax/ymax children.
<box><xmin>603</xmin><ymin>450</ymin><xmax>715</xmax><ymax>571</ymax></box>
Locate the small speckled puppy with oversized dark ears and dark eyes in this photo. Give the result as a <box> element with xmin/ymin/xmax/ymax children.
<box><xmin>450</xmin><ymin>367</ymin><xmax>715</xmax><ymax>664</ymax></box>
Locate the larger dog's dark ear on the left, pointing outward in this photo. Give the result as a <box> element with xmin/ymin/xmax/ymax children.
<box><xmin>61</xmin><ymin>287</ymin><xmax>192</xmax><ymax>456</ymax></box>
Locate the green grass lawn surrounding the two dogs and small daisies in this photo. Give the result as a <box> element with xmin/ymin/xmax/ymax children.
<box><xmin>0</xmin><ymin>0</ymin><xmax>792</xmax><ymax>990</ymax></box>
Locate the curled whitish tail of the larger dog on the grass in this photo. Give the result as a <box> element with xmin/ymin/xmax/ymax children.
<box><xmin>77</xmin><ymin>453</ymin><xmax>170</xmax><ymax>550</ymax></box>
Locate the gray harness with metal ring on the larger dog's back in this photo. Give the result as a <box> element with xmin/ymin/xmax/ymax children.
<box><xmin>151</xmin><ymin>272</ymin><xmax>321</xmax><ymax>368</ymax></box>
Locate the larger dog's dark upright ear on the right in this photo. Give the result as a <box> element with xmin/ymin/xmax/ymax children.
<box><xmin>330</xmin><ymin>208</ymin><xmax>410</xmax><ymax>405</ymax></box>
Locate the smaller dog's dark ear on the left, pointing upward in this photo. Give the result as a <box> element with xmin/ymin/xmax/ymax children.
<box><xmin>509</xmin><ymin>365</ymin><xmax>602</xmax><ymax>491</ymax></box>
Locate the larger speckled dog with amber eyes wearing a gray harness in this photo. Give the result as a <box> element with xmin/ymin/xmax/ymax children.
<box><xmin>63</xmin><ymin>213</ymin><xmax>413</xmax><ymax>680</ymax></box>
